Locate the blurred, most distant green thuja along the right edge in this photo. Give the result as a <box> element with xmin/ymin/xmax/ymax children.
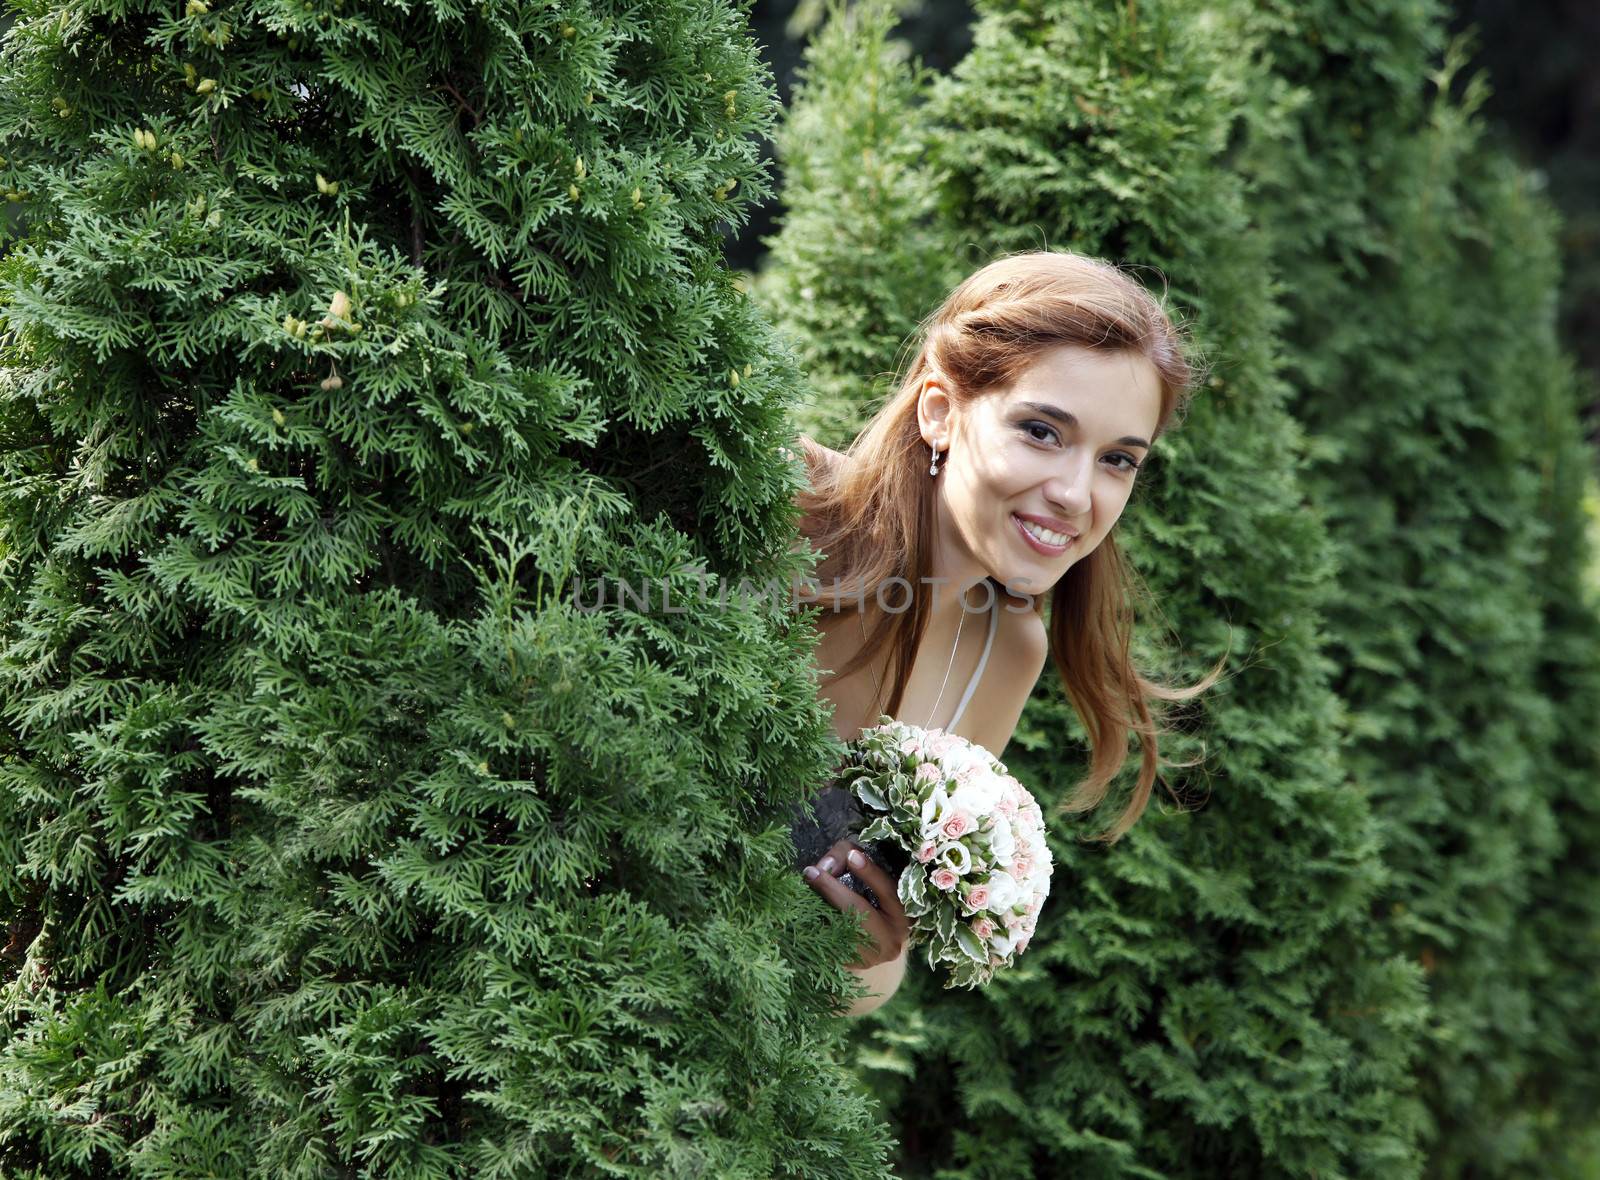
<box><xmin>1245</xmin><ymin>3</ymin><xmax>1600</xmax><ymax>1177</ymax></box>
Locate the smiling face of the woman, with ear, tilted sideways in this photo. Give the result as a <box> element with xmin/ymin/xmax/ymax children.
<box><xmin>917</xmin><ymin>344</ymin><xmax>1162</xmax><ymax>595</ymax></box>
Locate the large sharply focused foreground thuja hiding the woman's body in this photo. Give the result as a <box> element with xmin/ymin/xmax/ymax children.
<box><xmin>0</xmin><ymin>0</ymin><xmax>886</xmax><ymax>1177</ymax></box>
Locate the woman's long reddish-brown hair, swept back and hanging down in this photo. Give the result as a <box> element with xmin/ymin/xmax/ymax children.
<box><xmin>797</xmin><ymin>251</ymin><xmax>1227</xmax><ymax>844</ymax></box>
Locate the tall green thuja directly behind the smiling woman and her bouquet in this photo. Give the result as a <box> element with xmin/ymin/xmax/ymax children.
<box><xmin>758</xmin><ymin>0</ymin><xmax>1424</xmax><ymax>1177</ymax></box>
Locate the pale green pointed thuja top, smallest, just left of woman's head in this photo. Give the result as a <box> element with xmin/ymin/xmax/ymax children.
<box><xmin>752</xmin><ymin>3</ymin><xmax>966</xmax><ymax>448</ymax></box>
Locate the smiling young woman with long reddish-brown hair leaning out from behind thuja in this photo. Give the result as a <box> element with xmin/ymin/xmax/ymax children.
<box><xmin>797</xmin><ymin>251</ymin><xmax>1221</xmax><ymax>1015</ymax></box>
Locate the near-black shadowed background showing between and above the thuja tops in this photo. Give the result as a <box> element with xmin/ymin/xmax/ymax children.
<box><xmin>728</xmin><ymin>0</ymin><xmax>1600</xmax><ymax>444</ymax></box>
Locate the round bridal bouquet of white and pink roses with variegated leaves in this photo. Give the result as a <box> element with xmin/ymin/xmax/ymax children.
<box><xmin>840</xmin><ymin>716</ymin><xmax>1053</xmax><ymax>988</ymax></box>
